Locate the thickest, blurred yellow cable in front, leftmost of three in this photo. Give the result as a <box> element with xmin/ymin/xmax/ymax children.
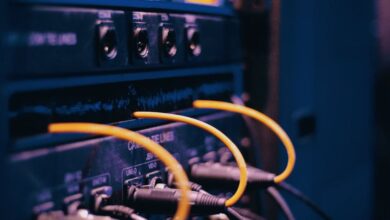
<box><xmin>49</xmin><ymin>123</ymin><xmax>190</xmax><ymax>220</ymax></box>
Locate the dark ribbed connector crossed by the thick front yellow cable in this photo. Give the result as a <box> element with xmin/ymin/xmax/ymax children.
<box><xmin>127</xmin><ymin>186</ymin><xmax>226</xmax><ymax>215</ymax></box>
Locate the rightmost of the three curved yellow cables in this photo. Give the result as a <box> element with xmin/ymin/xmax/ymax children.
<box><xmin>193</xmin><ymin>100</ymin><xmax>295</xmax><ymax>183</ymax></box>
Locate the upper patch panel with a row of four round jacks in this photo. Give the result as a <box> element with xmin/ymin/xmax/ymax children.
<box><xmin>8</xmin><ymin>6</ymin><xmax>240</xmax><ymax>78</ymax></box>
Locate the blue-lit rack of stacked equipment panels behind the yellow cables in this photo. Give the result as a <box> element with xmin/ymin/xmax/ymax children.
<box><xmin>0</xmin><ymin>0</ymin><xmax>258</xmax><ymax>219</ymax></box>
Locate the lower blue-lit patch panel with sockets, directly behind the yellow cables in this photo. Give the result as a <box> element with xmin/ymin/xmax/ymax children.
<box><xmin>4</xmin><ymin>113</ymin><xmax>253</xmax><ymax>219</ymax></box>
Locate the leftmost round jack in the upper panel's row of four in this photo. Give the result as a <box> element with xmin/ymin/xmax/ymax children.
<box><xmin>99</xmin><ymin>24</ymin><xmax>118</xmax><ymax>60</ymax></box>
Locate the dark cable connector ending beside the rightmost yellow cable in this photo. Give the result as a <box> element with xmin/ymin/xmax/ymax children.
<box><xmin>190</xmin><ymin>163</ymin><xmax>275</xmax><ymax>187</ymax></box>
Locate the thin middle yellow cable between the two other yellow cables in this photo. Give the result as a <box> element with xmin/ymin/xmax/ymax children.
<box><xmin>133</xmin><ymin>112</ymin><xmax>248</xmax><ymax>207</ymax></box>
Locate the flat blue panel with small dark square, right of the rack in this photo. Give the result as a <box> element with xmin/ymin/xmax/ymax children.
<box><xmin>280</xmin><ymin>0</ymin><xmax>378</xmax><ymax>219</ymax></box>
